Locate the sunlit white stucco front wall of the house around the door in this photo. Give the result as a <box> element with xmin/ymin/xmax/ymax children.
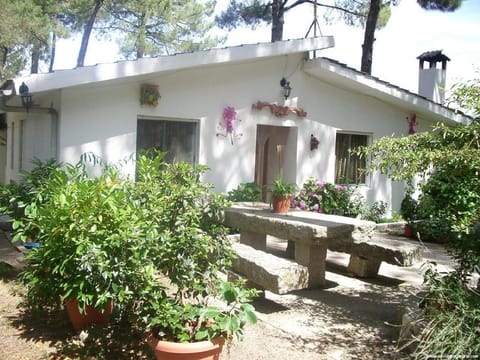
<box><xmin>49</xmin><ymin>55</ymin><xmax>442</xmax><ymax>212</ymax></box>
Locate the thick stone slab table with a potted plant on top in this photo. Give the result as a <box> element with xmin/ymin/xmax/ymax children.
<box><xmin>224</xmin><ymin>202</ymin><xmax>376</xmax><ymax>288</ymax></box>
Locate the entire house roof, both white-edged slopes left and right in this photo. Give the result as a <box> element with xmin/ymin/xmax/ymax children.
<box><xmin>15</xmin><ymin>36</ymin><xmax>471</xmax><ymax>124</ymax></box>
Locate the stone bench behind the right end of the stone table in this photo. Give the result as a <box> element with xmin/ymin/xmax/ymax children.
<box><xmin>328</xmin><ymin>235</ymin><xmax>424</xmax><ymax>277</ymax></box>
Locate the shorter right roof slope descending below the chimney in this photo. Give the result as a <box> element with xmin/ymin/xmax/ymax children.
<box><xmin>304</xmin><ymin>58</ymin><xmax>472</xmax><ymax>124</ymax></box>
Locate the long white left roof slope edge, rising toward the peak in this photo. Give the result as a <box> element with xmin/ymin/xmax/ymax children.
<box><xmin>15</xmin><ymin>36</ymin><xmax>334</xmax><ymax>93</ymax></box>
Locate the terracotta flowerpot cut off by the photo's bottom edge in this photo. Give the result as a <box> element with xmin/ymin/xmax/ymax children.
<box><xmin>147</xmin><ymin>335</ymin><xmax>225</xmax><ymax>360</ymax></box>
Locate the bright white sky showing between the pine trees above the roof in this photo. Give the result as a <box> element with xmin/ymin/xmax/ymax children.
<box><xmin>54</xmin><ymin>0</ymin><xmax>480</xmax><ymax>92</ymax></box>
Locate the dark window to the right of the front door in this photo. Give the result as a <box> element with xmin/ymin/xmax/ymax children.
<box><xmin>335</xmin><ymin>133</ymin><xmax>368</xmax><ymax>184</ymax></box>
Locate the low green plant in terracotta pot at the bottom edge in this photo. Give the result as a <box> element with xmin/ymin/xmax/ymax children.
<box><xmin>140</xmin><ymin>281</ymin><xmax>256</xmax><ymax>360</ymax></box>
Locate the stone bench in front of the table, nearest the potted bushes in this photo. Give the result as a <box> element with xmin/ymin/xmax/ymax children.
<box><xmin>232</xmin><ymin>243</ymin><xmax>308</xmax><ymax>294</ymax></box>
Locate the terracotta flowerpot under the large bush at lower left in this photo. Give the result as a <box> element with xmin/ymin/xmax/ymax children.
<box><xmin>65</xmin><ymin>300</ymin><xmax>113</xmax><ymax>332</ymax></box>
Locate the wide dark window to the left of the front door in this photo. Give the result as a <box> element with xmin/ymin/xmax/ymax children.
<box><xmin>137</xmin><ymin>119</ymin><xmax>198</xmax><ymax>164</ymax></box>
